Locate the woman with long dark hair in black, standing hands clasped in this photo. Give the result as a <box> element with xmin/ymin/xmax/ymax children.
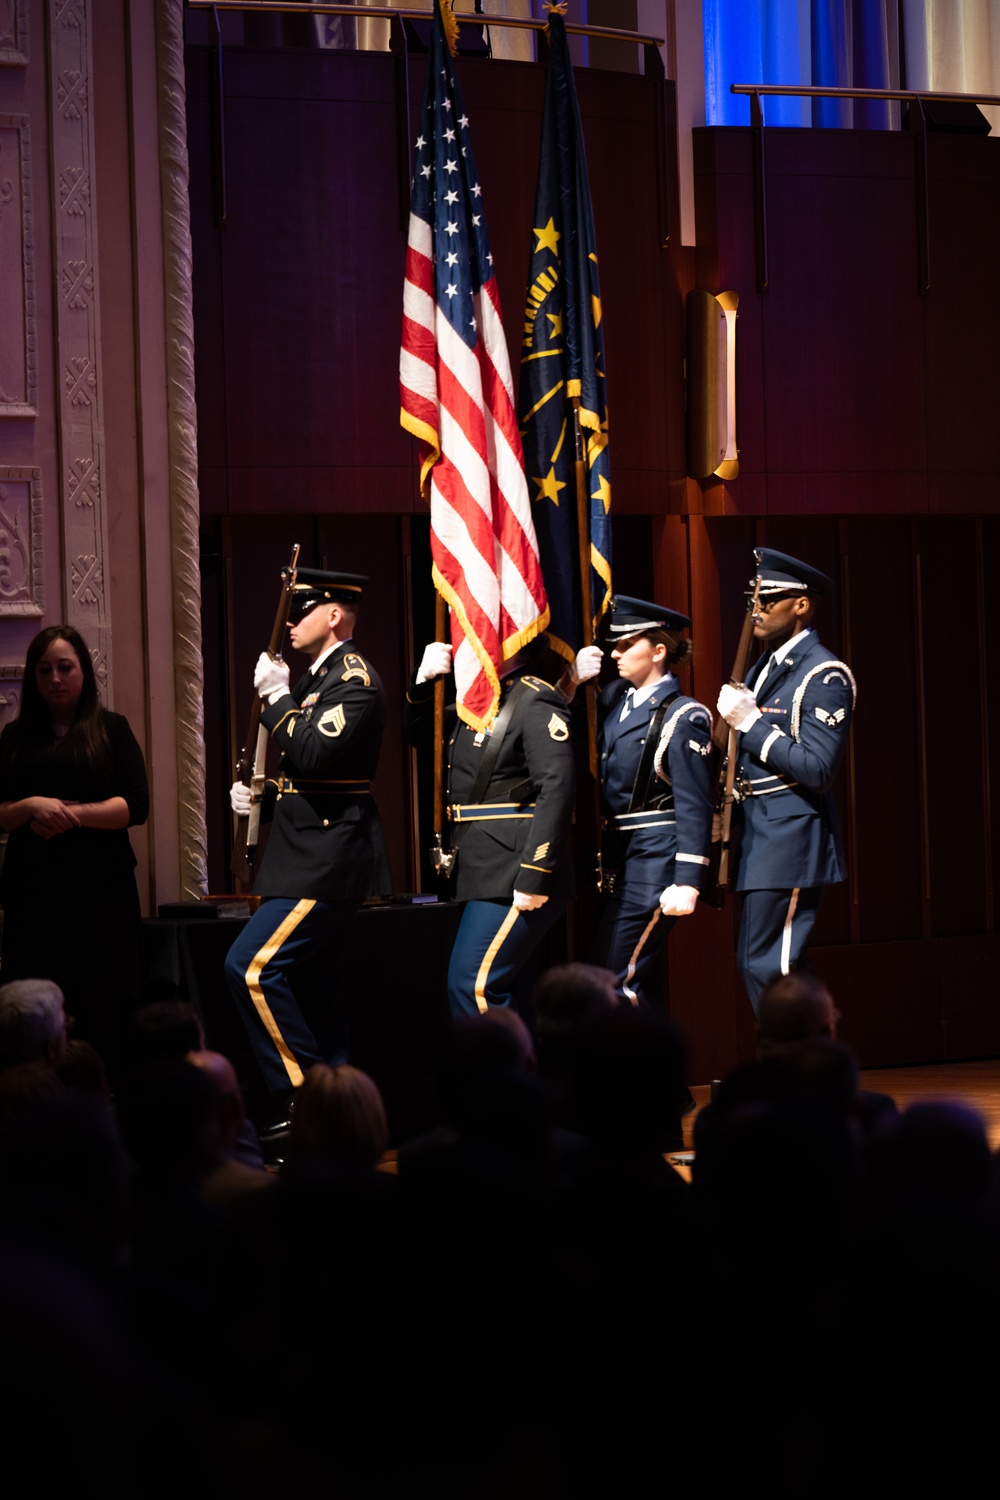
<box><xmin>0</xmin><ymin>626</ymin><xmax>150</xmax><ymax>1064</ymax></box>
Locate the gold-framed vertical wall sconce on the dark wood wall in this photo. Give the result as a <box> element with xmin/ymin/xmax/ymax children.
<box><xmin>687</xmin><ymin>291</ymin><xmax>739</xmax><ymax>479</ymax></box>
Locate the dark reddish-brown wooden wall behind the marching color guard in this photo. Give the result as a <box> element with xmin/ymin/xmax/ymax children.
<box><xmin>189</xmin><ymin>48</ymin><xmax>1000</xmax><ymax>1079</ymax></box>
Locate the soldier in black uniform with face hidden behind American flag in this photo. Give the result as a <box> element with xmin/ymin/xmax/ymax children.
<box><xmin>405</xmin><ymin>641</ymin><xmax>576</xmax><ymax>1016</ymax></box>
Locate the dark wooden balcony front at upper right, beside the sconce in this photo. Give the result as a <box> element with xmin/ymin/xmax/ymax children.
<box><xmin>694</xmin><ymin>120</ymin><xmax>1000</xmax><ymax>515</ymax></box>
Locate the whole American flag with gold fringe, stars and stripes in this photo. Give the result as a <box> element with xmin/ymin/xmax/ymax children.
<box><xmin>399</xmin><ymin>8</ymin><xmax>549</xmax><ymax>729</ymax></box>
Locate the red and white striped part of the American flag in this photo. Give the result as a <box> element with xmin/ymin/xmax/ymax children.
<box><xmin>399</xmin><ymin>215</ymin><xmax>549</xmax><ymax>729</ymax></box>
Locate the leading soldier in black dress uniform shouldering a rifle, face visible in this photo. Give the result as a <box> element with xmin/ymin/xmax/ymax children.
<box><xmin>226</xmin><ymin>569</ymin><xmax>391</xmax><ymax>1115</ymax></box>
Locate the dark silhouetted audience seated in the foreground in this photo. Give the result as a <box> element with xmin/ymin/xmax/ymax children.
<box><xmin>0</xmin><ymin>965</ymin><xmax>1000</xmax><ymax>1500</ymax></box>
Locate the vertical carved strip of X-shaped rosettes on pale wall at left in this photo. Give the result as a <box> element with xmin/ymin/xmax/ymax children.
<box><xmin>47</xmin><ymin>0</ymin><xmax>112</xmax><ymax>686</ymax></box>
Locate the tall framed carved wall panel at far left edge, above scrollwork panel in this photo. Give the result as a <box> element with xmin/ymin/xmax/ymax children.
<box><xmin>0</xmin><ymin>113</ymin><xmax>37</xmax><ymax>417</ymax></box>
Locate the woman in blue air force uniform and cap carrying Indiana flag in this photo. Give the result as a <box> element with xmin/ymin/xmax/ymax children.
<box><xmin>573</xmin><ymin>594</ymin><xmax>712</xmax><ymax>1004</ymax></box>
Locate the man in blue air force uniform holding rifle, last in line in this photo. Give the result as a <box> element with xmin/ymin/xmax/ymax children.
<box><xmin>718</xmin><ymin>548</ymin><xmax>858</xmax><ymax>1011</ymax></box>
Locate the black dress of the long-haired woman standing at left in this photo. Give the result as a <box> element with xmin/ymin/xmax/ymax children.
<box><xmin>0</xmin><ymin>710</ymin><xmax>150</xmax><ymax>1061</ymax></box>
